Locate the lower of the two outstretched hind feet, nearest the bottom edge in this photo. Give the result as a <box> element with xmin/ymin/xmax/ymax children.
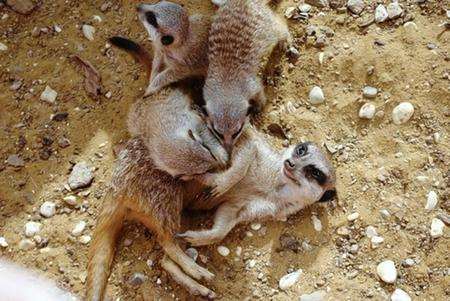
<box><xmin>161</xmin><ymin>255</ymin><xmax>216</xmax><ymax>299</ymax></box>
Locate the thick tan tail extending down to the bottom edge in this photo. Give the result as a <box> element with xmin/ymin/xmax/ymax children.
<box><xmin>86</xmin><ymin>191</ymin><xmax>126</xmax><ymax>301</ymax></box>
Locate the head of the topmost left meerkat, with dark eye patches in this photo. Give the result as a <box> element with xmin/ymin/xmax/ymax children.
<box><xmin>137</xmin><ymin>1</ymin><xmax>189</xmax><ymax>49</ymax></box>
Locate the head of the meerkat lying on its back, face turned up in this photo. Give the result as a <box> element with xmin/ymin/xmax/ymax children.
<box><xmin>282</xmin><ymin>142</ymin><xmax>336</xmax><ymax>206</ymax></box>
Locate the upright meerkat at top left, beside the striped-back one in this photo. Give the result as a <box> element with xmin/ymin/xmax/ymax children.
<box><xmin>137</xmin><ymin>1</ymin><xmax>211</xmax><ymax>96</ymax></box>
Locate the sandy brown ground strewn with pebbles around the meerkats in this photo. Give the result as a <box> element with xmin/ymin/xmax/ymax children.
<box><xmin>0</xmin><ymin>0</ymin><xmax>450</xmax><ymax>300</ymax></box>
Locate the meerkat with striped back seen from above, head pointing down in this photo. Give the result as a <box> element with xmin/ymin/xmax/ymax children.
<box><xmin>203</xmin><ymin>0</ymin><xmax>291</xmax><ymax>152</ymax></box>
